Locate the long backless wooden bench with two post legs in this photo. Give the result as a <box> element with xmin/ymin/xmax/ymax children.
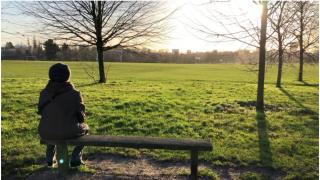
<box><xmin>40</xmin><ymin>135</ymin><xmax>212</xmax><ymax>179</ymax></box>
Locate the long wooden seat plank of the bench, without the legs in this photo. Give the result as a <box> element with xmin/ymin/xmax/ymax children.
<box><xmin>41</xmin><ymin>135</ymin><xmax>212</xmax><ymax>151</ymax></box>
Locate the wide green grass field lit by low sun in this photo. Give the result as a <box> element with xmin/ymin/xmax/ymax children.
<box><xmin>1</xmin><ymin>61</ymin><xmax>319</xmax><ymax>179</ymax></box>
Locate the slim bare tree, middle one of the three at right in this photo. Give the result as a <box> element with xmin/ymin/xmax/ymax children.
<box><xmin>268</xmin><ymin>1</ymin><xmax>296</xmax><ymax>88</ymax></box>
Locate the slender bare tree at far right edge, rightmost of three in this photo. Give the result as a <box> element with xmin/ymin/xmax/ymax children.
<box><xmin>293</xmin><ymin>1</ymin><xmax>319</xmax><ymax>81</ymax></box>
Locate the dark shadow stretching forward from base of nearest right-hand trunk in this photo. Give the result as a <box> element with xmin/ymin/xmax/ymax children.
<box><xmin>256</xmin><ymin>111</ymin><xmax>273</xmax><ymax>167</ymax></box>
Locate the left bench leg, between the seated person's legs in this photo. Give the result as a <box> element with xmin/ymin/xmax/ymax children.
<box><xmin>57</xmin><ymin>144</ymin><xmax>69</xmax><ymax>176</ymax></box>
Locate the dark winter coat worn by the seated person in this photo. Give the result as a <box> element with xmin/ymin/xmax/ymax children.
<box><xmin>38</xmin><ymin>81</ymin><xmax>87</xmax><ymax>140</ymax></box>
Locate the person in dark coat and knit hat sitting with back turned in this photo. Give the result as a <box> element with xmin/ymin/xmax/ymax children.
<box><xmin>38</xmin><ymin>63</ymin><xmax>89</xmax><ymax>167</ymax></box>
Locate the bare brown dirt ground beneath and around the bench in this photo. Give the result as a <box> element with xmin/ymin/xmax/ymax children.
<box><xmin>28</xmin><ymin>154</ymin><xmax>284</xmax><ymax>180</ymax></box>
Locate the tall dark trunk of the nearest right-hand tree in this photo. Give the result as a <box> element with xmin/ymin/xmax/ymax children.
<box><xmin>256</xmin><ymin>1</ymin><xmax>268</xmax><ymax>111</ymax></box>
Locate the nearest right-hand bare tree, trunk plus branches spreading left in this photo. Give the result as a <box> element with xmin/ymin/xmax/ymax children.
<box><xmin>191</xmin><ymin>0</ymin><xmax>268</xmax><ymax>110</ymax></box>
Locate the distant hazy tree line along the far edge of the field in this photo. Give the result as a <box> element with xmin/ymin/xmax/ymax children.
<box><xmin>1</xmin><ymin>38</ymin><xmax>319</xmax><ymax>65</ymax></box>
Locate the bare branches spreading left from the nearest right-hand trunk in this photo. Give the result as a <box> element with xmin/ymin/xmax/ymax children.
<box><xmin>188</xmin><ymin>1</ymin><xmax>260</xmax><ymax>48</ymax></box>
